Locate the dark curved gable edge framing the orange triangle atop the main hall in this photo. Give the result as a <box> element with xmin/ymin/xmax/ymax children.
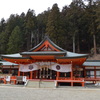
<box><xmin>29</xmin><ymin>36</ymin><xmax>65</xmax><ymax>52</ymax></box>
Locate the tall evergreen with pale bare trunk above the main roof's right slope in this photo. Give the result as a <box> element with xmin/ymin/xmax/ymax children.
<box><xmin>67</xmin><ymin>0</ymin><xmax>84</xmax><ymax>52</ymax></box>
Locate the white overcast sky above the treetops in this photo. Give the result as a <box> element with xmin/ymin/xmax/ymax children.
<box><xmin>0</xmin><ymin>0</ymin><xmax>72</xmax><ymax>20</ymax></box>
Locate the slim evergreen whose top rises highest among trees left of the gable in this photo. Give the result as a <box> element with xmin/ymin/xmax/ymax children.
<box><xmin>24</xmin><ymin>9</ymin><xmax>37</xmax><ymax>50</ymax></box>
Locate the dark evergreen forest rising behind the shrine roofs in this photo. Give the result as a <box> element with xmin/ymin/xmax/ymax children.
<box><xmin>0</xmin><ymin>0</ymin><xmax>100</xmax><ymax>54</ymax></box>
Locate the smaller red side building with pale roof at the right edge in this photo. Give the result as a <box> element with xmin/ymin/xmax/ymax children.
<box><xmin>83</xmin><ymin>60</ymin><xmax>100</xmax><ymax>83</ymax></box>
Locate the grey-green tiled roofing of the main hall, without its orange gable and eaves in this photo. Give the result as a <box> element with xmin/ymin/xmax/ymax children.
<box><xmin>2</xmin><ymin>37</ymin><xmax>88</xmax><ymax>59</ymax></box>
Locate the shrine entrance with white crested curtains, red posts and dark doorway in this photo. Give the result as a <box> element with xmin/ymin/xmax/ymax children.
<box><xmin>19</xmin><ymin>62</ymin><xmax>72</xmax><ymax>80</ymax></box>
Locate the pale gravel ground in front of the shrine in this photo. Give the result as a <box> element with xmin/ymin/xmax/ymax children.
<box><xmin>0</xmin><ymin>86</ymin><xmax>100</xmax><ymax>100</ymax></box>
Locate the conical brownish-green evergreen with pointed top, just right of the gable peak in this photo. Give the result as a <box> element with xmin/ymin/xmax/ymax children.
<box><xmin>46</xmin><ymin>4</ymin><xmax>63</xmax><ymax>45</ymax></box>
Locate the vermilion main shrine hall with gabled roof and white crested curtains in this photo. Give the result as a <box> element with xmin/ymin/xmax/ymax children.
<box><xmin>2</xmin><ymin>37</ymin><xmax>100</xmax><ymax>86</ymax></box>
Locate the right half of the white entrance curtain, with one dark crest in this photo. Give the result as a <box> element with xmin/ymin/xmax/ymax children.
<box><xmin>49</xmin><ymin>64</ymin><xmax>72</xmax><ymax>72</ymax></box>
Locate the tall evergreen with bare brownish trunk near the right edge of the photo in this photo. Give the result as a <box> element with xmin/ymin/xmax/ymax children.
<box><xmin>86</xmin><ymin>0</ymin><xmax>97</xmax><ymax>55</ymax></box>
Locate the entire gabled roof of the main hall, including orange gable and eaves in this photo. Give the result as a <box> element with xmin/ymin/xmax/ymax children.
<box><xmin>2</xmin><ymin>36</ymin><xmax>88</xmax><ymax>63</ymax></box>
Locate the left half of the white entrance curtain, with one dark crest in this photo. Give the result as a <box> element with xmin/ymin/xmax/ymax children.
<box><xmin>19</xmin><ymin>64</ymin><xmax>39</xmax><ymax>72</ymax></box>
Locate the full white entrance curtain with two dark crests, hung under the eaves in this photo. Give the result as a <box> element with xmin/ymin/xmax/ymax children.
<box><xmin>19</xmin><ymin>62</ymin><xmax>72</xmax><ymax>72</ymax></box>
